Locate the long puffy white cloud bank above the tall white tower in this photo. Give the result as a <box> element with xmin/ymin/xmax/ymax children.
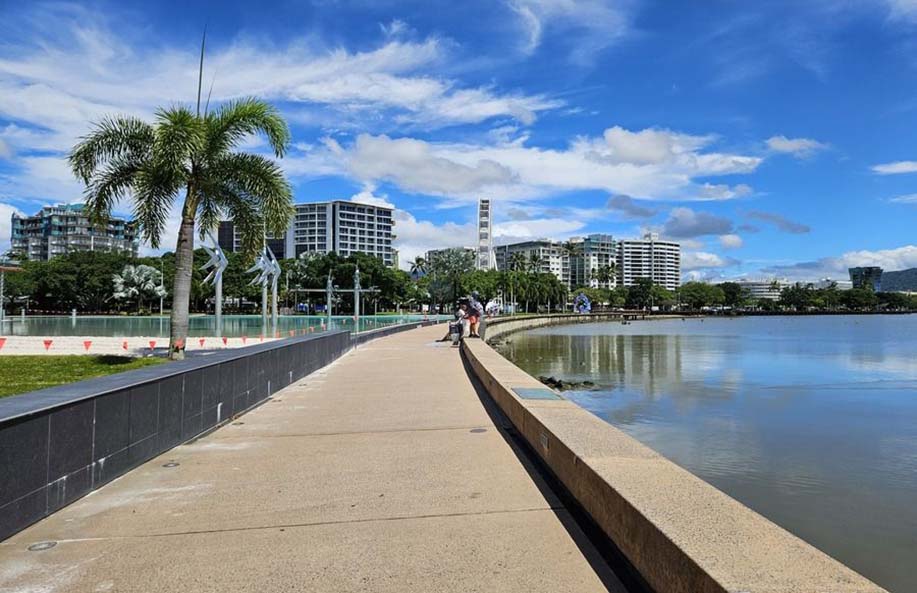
<box><xmin>332</xmin><ymin>127</ymin><xmax>761</xmax><ymax>200</ymax></box>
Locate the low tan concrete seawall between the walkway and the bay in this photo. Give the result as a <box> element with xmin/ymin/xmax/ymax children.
<box><xmin>462</xmin><ymin>319</ymin><xmax>885</xmax><ymax>593</ymax></box>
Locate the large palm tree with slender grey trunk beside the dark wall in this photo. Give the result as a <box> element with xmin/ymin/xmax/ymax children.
<box><xmin>69</xmin><ymin>95</ymin><xmax>293</xmax><ymax>359</ymax></box>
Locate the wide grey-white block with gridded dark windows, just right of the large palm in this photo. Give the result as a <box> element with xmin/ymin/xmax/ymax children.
<box><xmin>218</xmin><ymin>200</ymin><xmax>395</xmax><ymax>266</ymax></box>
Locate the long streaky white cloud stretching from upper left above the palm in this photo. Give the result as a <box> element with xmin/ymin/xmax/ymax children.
<box><xmin>0</xmin><ymin>5</ymin><xmax>562</xmax><ymax>162</ymax></box>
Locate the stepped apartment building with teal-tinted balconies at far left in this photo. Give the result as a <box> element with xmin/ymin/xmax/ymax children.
<box><xmin>11</xmin><ymin>204</ymin><xmax>140</xmax><ymax>260</ymax></box>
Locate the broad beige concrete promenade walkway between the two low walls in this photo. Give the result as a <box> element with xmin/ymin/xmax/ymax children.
<box><xmin>0</xmin><ymin>327</ymin><xmax>623</xmax><ymax>593</ymax></box>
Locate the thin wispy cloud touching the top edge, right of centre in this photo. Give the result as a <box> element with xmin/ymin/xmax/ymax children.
<box><xmin>507</xmin><ymin>0</ymin><xmax>634</xmax><ymax>62</ymax></box>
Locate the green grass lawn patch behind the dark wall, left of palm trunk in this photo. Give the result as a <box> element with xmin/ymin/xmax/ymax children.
<box><xmin>0</xmin><ymin>355</ymin><xmax>166</xmax><ymax>397</ymax></box>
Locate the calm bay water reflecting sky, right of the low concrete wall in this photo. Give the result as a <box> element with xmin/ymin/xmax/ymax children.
<box><xmin>499</xmin><ymin>315</ymin><xmax>917</xmax><ymax>593</ymax></box>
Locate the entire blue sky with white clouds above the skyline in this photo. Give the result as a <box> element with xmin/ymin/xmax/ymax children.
<box><xmin>0</xmin><ymin>0</ymin><xmax>917</xmax><ymax>279</ymax></box>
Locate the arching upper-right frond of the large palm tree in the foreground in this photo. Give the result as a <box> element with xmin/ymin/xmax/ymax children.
<box><xmin>205</xmin><ymin>98</ymin><xmax>291</xmax><ymax>157</ymax></box>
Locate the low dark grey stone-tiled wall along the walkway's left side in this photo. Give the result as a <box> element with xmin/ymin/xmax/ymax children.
<box><xmin>0</xmin><ymin>326</ymin><xmax>350</xmax><ymax>540</ymax></box>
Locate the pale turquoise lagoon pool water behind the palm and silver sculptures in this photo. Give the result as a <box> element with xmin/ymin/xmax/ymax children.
<box><xmin>0</xmin><ymin>315</ymin><xmax>444</xmax><ymax>338</ymax></box>
